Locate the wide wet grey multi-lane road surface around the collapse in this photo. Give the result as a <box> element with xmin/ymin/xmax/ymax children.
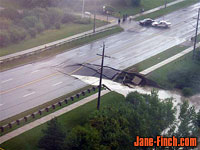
<box><xmin>0</xmin><ymin>3</ymin><xmax>200</xmax><ymax>120</ymax></box>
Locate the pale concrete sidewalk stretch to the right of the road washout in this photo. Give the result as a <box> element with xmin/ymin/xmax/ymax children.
<box><xmin>140</xmin><ymin>43</ymin><xmax>200</xmax><ymax>75</ymax></box>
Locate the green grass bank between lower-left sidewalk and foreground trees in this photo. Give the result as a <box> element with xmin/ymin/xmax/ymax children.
<box><xmin>0</xmin><ymin>92</ymin><xmax>124</xmax><ymax>150</ymax></box>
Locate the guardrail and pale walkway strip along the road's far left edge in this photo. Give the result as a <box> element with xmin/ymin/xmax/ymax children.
<box><xmin>0</xmin><ymin>24</ymin><xmax>117</xmax><ymax>64</ymax></box>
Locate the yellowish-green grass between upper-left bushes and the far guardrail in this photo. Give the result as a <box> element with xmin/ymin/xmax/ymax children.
<box><xmin>0</xmin><ymin>20</ymin><xmax>107</xmax><ymax>56</ymax></box>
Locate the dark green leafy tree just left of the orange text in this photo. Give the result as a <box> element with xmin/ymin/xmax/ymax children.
<box><xmin>90</xmin><ymin>103</ymin><xmax>132</xmax><ymax>150</ymax></box>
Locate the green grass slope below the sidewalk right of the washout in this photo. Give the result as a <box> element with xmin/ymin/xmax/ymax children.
<box><xmin>147</xmin><ymin>52</ymin><xmax>200</xmax><ymax>89</ymax></box>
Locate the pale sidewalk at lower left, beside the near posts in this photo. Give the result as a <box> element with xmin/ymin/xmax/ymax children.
<box><xmin>0</xmin><ymin>90</ymin><xmax>110</xmax><ymax>144</ymax></box>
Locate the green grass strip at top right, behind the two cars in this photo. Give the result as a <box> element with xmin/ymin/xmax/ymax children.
<box><xmin>136</xmin><ymin>0</ymin><xmax>199</xmax><ymax>20</ymax></box>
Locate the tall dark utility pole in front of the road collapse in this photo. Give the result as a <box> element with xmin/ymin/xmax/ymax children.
<box><xmin>97</xmin><ymin>43</ymin><xmax>105</xmax><ymax>110</ymax></box>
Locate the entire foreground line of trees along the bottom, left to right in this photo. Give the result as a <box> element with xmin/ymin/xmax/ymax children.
<box><xmin>38</xmin><ymin>91</ymin><xmax>200</xmax><ymax>150</ymax></box>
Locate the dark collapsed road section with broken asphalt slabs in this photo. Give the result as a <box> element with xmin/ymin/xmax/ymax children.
<box><xmin>63</xmin><ymin>63</ymin><xmax>159</xmax><ymax>87</ymax></box>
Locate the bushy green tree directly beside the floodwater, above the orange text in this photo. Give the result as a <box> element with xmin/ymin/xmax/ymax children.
<box><xmin>126</xmin><ymin>90</ymin><xmax>176</xmax><ymax>137</ymax></box>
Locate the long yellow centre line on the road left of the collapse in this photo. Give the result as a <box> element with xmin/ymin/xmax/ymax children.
<box><xmin>0</xmin><ymin>72</ymin><xmax>59</xmax><ymax>95</ymax></box>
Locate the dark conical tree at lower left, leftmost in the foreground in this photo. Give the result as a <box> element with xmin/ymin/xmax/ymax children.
<box><xmin>38</xmin><ymin>118</ymin><xmax>65</xmax><ymax>150</ymax></box>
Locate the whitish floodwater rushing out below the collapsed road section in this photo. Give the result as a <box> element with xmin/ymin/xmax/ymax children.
<box><xmin>74</xmin><ymin>75</ymin><xmax>200</xmax><ymax>110</ymax></box>
